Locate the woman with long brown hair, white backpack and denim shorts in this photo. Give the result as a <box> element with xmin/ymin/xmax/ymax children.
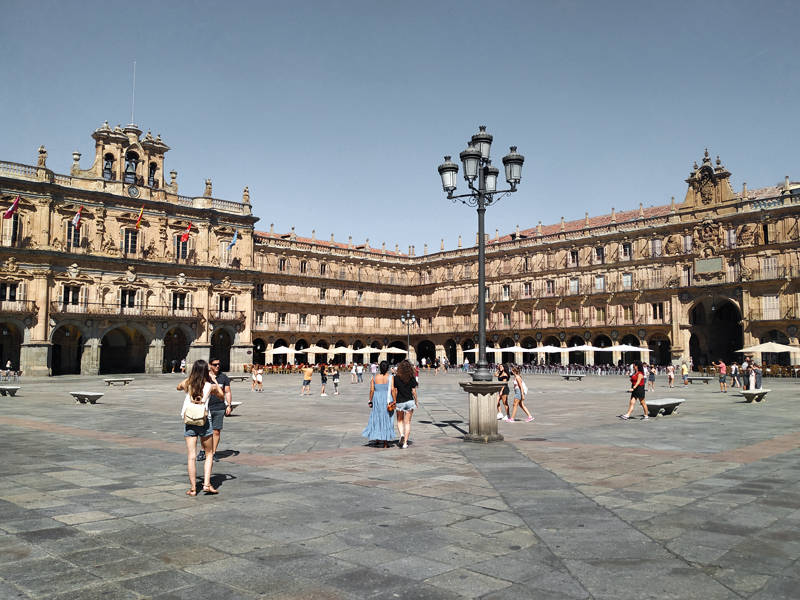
<box><xmin>177</xmin><ymin>360</ymin><xmax>225</xmax><ymax>496</ymax></box>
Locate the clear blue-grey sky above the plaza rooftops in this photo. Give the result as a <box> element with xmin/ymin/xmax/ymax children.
<box><xmin>0</xmin><ymin>0</ymin><xmax>800</xmax><ymax>254</ymax></box>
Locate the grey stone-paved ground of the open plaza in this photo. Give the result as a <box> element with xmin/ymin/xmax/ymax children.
<box><xmin>0</xmin><ymin>373</ymin><xmax>800</xmax><ymax>600</ymax></box>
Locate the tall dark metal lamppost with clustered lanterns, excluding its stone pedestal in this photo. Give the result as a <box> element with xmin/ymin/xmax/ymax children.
<box><xmin>439</xmin><ymin>125</ymin><xmax>525</xmax><ymax>381</ymax></box>
